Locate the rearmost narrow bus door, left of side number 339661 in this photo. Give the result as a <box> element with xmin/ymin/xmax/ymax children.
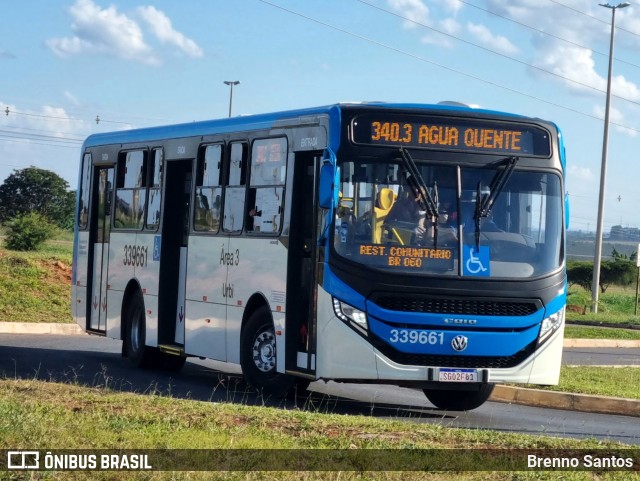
<box><xmin>88</xmin><ymin>167</ymin><xmax>114</xmax><ymax>333</ymax></box>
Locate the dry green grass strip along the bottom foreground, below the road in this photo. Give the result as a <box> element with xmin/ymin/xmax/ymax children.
<box><xmin>0</xmin><ymin>379</ymin><xmax>640</xmax><ymax>481</ymax></box>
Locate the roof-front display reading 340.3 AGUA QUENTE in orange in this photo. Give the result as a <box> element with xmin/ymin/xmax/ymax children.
<box><xmin>352</xmin><ymin>112</ymin><xmax>551</xmax><ymax>157</ymax></box>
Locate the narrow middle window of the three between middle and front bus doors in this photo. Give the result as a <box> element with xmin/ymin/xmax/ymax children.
<box><xmin>222</xmin><ymin>142</ymin><xmax>248</xmax><ymax>233</ymax></box>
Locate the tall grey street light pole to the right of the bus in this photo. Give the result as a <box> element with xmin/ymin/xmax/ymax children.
<box><xmin>591</xmin><ymin>2</ymin><xmax>630</xmax><ymax>313</ymax></box>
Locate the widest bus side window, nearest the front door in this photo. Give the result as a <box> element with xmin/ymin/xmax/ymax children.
<box><xmin>247</xmin><ymin>137</ymin><xmax>287</xmax><ymax>235</ymax></box>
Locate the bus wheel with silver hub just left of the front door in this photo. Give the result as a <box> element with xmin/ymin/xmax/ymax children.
<box><xmin>240</xmin><ymin>306</ymin><xmax>296</xmax><ymax>398</ymax></box>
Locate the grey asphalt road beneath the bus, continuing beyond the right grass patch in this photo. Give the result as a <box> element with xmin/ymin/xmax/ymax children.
<box><xmin>0</xmin><ymin>334</ymin><xmax>640</xmax><ymax>445</ymax></box>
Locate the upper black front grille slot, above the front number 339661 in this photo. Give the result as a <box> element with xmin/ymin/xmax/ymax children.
<box><xmin>371</xmin><ymin>295</ymin><xmax>542</xmax><ymax>316</ymax></box>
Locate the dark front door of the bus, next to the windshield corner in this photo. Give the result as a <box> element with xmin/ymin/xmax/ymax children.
<box><xmin>286</xmin><ymin>152</ymin><xmax>322</xmax><ymax>379</ymax></box>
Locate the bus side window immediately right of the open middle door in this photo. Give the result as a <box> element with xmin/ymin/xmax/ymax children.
<box><xmin>193</xmin><ymin>144</ymin><xmax>222</xmax><ymax>232</ymax></box>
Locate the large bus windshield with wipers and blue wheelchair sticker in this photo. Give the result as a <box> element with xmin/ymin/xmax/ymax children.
<box><xmin>333</xmin><ymin>158</ymin><xmax>563</xmax><ymax>278</ymax></box>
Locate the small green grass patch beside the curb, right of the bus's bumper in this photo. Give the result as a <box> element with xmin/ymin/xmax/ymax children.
<box><xmin>528</xmin><ymin>366</ymin><xmax>640</xmax><ymax>399</ymax></box>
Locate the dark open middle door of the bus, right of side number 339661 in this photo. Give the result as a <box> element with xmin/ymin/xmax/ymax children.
<box><xmin>158</xmin><ymin>159</ymin><xmax>193</xmax><ymax>352</ymax></box>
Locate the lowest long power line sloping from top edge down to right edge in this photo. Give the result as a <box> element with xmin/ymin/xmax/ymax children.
<box><xmin>258</xmin><ymin>0</ymin><xmax>640</xmax><ymax>133</ymax></box>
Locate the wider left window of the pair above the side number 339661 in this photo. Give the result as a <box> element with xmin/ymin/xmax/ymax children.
<box><xmin>114</xmin><ymin>150</ymin><xmax>147</xmax><ymax>229</ymax></box>
